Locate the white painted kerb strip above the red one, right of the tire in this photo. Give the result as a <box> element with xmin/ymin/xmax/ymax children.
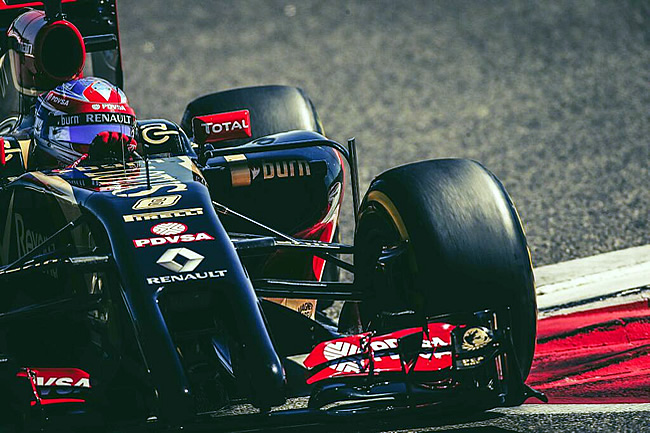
<box><xmin>535</xmin><ymin>245</ymin><xmax>650</xmax><ymax>314</ymax></box>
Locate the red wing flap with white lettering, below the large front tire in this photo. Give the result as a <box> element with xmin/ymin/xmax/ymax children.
<box><xmin>304</xmin><ymin>322</ymin><xmax>455</xmax><ymax>384</ymax></box>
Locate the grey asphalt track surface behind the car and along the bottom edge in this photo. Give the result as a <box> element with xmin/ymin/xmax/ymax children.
<box><xmin>114</xmin><ymin>0</ymin><xmax>650</xmax><ymax>433</ymax></box>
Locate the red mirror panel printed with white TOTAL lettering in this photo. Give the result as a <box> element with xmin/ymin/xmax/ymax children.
<box><xmin>192</xmin><ymin>110</ymin><xmax>252</xmax><ymax>144</ymax></box>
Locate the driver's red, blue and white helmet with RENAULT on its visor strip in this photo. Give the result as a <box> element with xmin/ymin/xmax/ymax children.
<box><xmin>34</xmin><ymin>77</ymin><xmax>136</xmax><ymax>167</ymax></box>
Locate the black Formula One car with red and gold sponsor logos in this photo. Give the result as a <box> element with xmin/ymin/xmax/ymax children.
<box><xmin>0</xmin><ymin>0</ymin><xmax>542</xmax><ymax>431</ymax></box>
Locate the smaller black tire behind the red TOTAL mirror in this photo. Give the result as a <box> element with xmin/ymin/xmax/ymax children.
<box><xmin>181</xmin><ymin>86</ymin><xmax>324</xmax><ymax>146</ymax></box>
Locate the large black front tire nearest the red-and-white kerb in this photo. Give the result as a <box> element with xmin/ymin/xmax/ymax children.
<box><xmin>355</xmin><ymin>159</ymin><xmax>537</xmax><ymax>379</ymax></box>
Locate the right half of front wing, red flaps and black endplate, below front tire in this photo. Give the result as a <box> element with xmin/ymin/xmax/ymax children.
<box><xmin>304</xmin><ymin>309</ymin><xmax>544</xmax><ymax>412</ymax></box>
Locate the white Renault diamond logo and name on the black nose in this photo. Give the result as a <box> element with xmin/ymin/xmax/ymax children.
<box><xmin>147</xmin><ymin>248</ymin><xmax>227</xmax><ymax>285</ymax></box>
